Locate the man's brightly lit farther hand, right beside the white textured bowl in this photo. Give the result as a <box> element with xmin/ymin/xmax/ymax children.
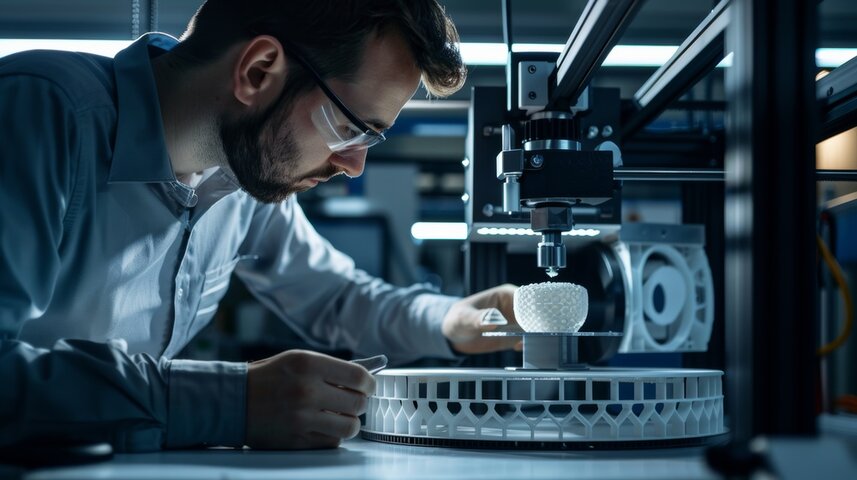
<box><xmin>443</xmin><ymin>284</ymin><xmax>522</xmax><ymax>353</ymax></box>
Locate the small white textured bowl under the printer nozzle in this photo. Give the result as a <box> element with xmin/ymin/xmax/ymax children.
<box><xmin>514</xmin><ymin>282</ymin><xmax>589</xmax><ymax>333</ymax></box>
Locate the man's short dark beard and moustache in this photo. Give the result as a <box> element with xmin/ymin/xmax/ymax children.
<box><xmin>219</xmin><ymin>98</ymin><xmax>340</xmax><ymax>203</ymax></box>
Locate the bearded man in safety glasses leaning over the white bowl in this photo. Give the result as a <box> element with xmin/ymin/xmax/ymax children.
<box><xmin>0</xmin><ymin>0</ymin><xmax>514</xmax><ymax>451</ymax></box>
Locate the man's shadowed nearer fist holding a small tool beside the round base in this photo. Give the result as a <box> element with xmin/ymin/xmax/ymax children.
<box><xmin>245</xmin><ymin>350</ymin><xmax>375</xmax><ymax>449</ymax></box>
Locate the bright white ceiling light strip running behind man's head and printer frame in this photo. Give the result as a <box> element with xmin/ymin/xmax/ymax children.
<box><xmin>0</xmin><ymin>38</ymin><xmax>857</xmax><ymax>68</ymax></box>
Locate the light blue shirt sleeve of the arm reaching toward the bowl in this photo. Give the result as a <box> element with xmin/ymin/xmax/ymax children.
<box><xmin>236</xmin><ymin>198</ymin><xmax>458</xmax><ymax>363</ymax></box>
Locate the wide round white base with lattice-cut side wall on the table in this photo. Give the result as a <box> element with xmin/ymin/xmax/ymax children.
<box><xmin>364</xmin><ymin>370</ymin><xmax>724</xmax><ymax>442</ymax></box>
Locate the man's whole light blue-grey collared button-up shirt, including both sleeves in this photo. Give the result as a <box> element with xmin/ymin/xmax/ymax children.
<box><xmin>0</xmin><ymin>34</ymin><xmax>456</xmax><ymax>451</ymax></box>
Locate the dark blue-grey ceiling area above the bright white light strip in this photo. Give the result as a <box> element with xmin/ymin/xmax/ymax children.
<box><xmin>0</xmin><ymin>0</ymin><xmax>857</xmax><ymax>47</ymax></box>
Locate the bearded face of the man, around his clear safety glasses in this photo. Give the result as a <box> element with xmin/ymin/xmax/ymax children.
<box><xmin>220</xmin><ymin>30</ymin><xmax>420</xmax><ymax>203</ymax></box>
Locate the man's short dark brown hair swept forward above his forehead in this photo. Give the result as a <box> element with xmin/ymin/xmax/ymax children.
<box><xmin>173</xmin><ymin>0</ymin><xmax>467</xmax><ymax>96</ymax></box>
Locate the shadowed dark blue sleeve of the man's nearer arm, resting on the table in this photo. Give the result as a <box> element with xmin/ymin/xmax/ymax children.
<box><xmin>0</xmin><ymin>75</ymin><xmax>246</xmax><ymax>451</ymax></box>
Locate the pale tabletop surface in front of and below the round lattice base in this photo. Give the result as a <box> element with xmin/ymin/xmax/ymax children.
<box><xmin>24</xmin><ymin>439</ymin><xmax>717</xmax><ymax>480</ymax></box>
